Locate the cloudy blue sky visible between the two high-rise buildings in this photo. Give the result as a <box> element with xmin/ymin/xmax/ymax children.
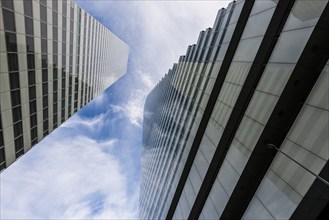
<box><xmin>0</xmin><ymin>0</ymin><xmax>228</xmax><ymax>219</ymax></box>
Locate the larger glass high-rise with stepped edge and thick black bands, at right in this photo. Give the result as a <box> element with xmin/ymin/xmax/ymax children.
<box><xmin>140</xmin><ymin>0</ymin><xmax>329</xmax><ymax>219</ymax></box>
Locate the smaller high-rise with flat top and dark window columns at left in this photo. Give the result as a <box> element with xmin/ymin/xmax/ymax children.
<box><xmin>0</xmin><ymin>0</ymin><xmax>128</xmax><ymax>170</ymax></box>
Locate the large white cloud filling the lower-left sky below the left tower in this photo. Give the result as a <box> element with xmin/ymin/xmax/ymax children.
<box><xmin>1</xmin><ymin>121</ymin><xmax>138</xmax><ymax>219</ymax></box>
